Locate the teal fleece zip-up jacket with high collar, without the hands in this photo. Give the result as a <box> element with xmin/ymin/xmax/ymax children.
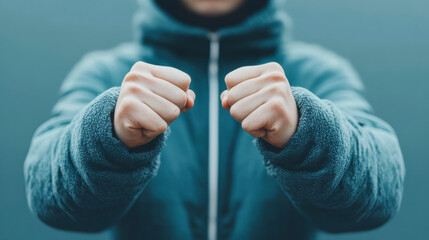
<box><xmin>24</xmin><ymin>0</ymin><xmax>405</xmax><ymax>239</ymax></box>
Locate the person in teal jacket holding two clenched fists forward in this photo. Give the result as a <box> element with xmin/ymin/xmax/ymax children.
<box><xmin>24</xmin><ymin>0</ymin><xmax>405</xmax><ymax>240</ymax></box>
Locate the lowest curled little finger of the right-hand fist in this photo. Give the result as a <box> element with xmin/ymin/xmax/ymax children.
<box><xmin>241</xmin><ymin>104</ymin><xmax>276</xmax><ymax>137</ymax></box>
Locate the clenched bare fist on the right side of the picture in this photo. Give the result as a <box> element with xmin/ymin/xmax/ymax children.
<box><xmin>221</xmin><ymin>63</ymin><xmax>298</xmax><ymax>148</ymax></box>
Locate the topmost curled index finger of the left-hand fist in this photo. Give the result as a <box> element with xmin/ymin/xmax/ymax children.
<box><xmin>131</xmin><ymin>62</ymin><xmax>191</xmax><ymax>91</ymax></box>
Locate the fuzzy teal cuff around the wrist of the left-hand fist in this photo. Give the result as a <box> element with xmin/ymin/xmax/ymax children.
<box><xmin>75</xmin><ymin>87</ymin><xmax>167</xmax><ymax>170</ymax></box>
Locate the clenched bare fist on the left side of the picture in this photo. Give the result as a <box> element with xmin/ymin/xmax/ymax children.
<box><xmin>114</xmin><ymin>62</ymin><xmax>195</xmax><ymax>148</ymax></box>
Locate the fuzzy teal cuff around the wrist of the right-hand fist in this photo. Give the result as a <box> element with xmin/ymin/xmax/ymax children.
<box><xmin>255</xmin><ymin>87</ymin><xmax>340</xmax><ymax>169</ymax></box>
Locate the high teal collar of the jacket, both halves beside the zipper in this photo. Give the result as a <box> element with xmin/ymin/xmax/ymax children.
<box><xmin>134</xmin><ymin>0</ymin><xmax>290</xmax><ymax>52</ymax></box>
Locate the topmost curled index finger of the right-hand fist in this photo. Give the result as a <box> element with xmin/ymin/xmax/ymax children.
<box><xmin>225</xmin><ymin>62</ymin><xmax>284</xmax><ymax>90</ymax></box>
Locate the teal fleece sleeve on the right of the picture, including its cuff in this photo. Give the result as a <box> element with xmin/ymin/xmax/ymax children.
<box><xmin>256</xmin><ymin>47</ymin><xmax>405</xmax><ymax>232</ymax></box>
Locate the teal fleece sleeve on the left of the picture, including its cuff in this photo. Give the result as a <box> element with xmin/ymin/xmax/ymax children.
<box><xmin>24</xmin><ymin>54</ymin><xmax>165</xmax><ymax>231</ymax></box>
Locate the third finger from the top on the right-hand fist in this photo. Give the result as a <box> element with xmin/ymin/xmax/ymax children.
<box><xmin>229</xmin><ymin>91</ymin><xmax>272</xmax><ymax>122</ymax></box>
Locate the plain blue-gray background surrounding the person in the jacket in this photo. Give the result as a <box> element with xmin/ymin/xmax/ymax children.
<box><xmin>0</xmin><ymin>0</ymin><xmax>429</xmax><ymax>240</ymax></box>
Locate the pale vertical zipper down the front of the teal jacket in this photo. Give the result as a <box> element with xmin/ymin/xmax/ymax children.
<box><xmin>207</xmin><ymin>32</ymin><xmax>219</xmax><ymax>240</ymax></box>
